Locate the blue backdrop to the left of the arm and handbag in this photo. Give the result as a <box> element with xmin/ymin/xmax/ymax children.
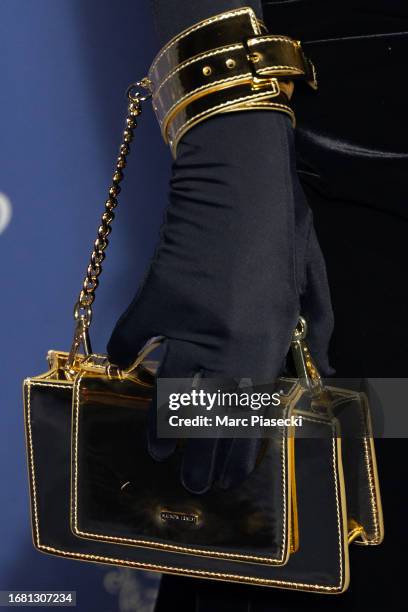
<box><xmin>0</xmin><ymin>0</ymin><xmax>171</xmax><ymax>612</ymax></box>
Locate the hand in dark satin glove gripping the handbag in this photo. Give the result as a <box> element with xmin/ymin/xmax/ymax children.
<box><xmin>108</xmin><ymin>111</ymin><xmax>333</xmax><ymax>493</ymax></box>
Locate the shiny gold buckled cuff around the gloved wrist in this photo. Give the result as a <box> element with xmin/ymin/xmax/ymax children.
<box><xmin>147</xmin><ymin>8</ymin><xmax>317</xmax><ymax>156</ymax></box>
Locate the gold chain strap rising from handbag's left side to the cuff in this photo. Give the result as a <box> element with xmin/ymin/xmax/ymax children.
<box><xmin>66</xmin><ymin>79</ymin><xmax>151</xmax><ymax>371</ymax></box>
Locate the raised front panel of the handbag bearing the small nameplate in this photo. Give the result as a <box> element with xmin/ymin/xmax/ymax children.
<box><xmin>72</xmin><ymin>376</ymin><xmax>292</xmax><ymax>564</ymax></box>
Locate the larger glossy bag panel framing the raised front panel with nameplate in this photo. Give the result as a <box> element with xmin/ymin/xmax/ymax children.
<box><xmin>24</xmin><ymin>378</ymin><xmax>349</xmax><ymax>593</ymax></box>
